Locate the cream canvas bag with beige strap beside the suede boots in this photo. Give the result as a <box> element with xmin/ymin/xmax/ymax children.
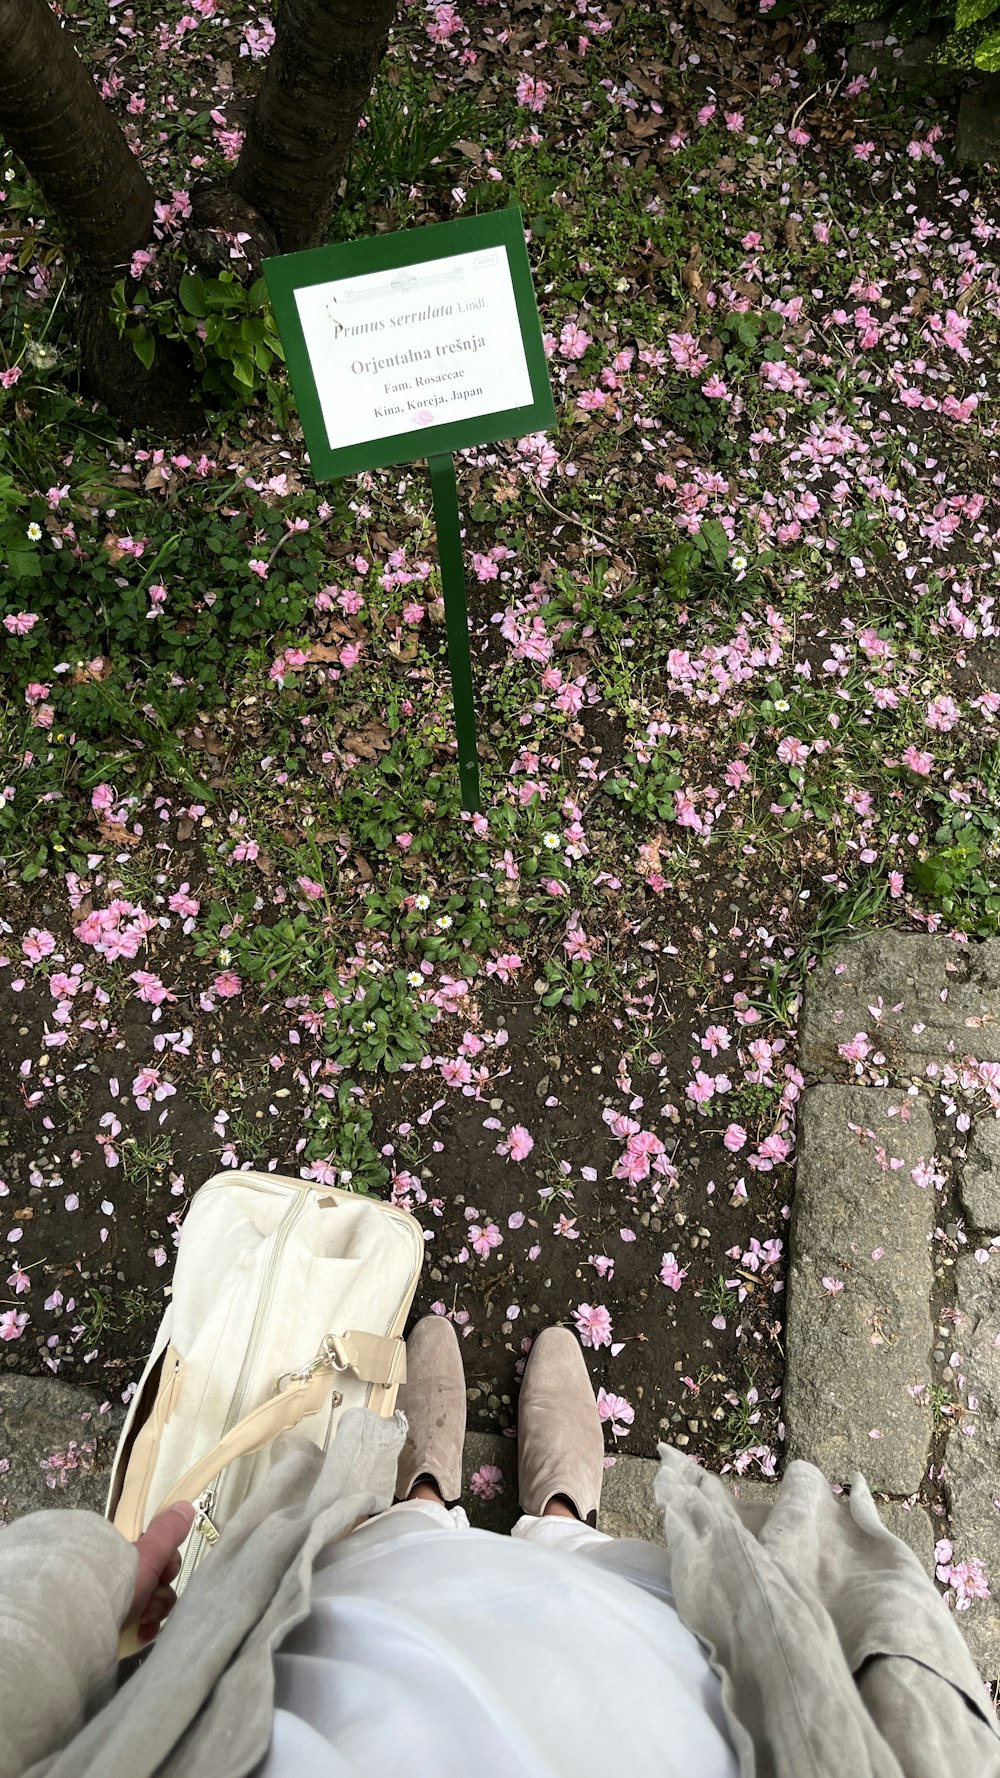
<box><xmin>105</xmin><ymin>1173</ymin><xmax>423</xmax><ymax>1628</ymax></box>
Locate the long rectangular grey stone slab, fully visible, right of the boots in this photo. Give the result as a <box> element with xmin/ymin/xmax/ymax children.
<box><xmin>785</xmin><ymin>1086</ymin><xmax>938</xmax><ymax>1495</ymax></box>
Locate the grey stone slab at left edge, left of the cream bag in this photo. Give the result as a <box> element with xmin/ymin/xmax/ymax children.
<box><xmin>0</xmin><ymin>1373</ymin><xmax>125</xmax><ymax>1522</ymax></box>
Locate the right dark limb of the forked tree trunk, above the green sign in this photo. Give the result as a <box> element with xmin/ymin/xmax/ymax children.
<box><xmin>227</xmin><ymin>0</ymin><xmax>395</xmax><ymax>252</ymax></box>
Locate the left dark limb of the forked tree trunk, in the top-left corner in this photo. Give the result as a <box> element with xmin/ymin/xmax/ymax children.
<box><xmin>0</xmin><ymin>0</ymin><xmax>153</xmax><ymax>284</ymax></box>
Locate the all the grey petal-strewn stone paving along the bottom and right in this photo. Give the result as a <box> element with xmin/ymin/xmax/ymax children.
<box><xmin>0</xmin><ymin>933</ymin><xmax>1000</xmax><ymax>1684</ymax></box>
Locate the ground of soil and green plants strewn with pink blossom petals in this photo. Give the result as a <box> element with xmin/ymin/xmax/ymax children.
<box><xmin>0</xmin><ymin>0</ymin><xmax>1000</xmax><ymax>1486</ymax></box>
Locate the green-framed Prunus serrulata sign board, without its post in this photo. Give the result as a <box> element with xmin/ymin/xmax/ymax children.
<box><xmin>263</xmin><ymin>208</ymin><xmax>555</xmax><ymax>480</ymax></box>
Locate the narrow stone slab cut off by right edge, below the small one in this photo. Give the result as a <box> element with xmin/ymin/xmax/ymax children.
<box><xmin>945</xmin><ymin>1250</ymin><xmax>1000</xmax><ymax>1680</ymax></box>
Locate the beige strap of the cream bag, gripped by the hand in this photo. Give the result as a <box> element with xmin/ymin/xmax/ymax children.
<box><xmin>134</xmin><ymin>1330</ymin><xmax>406</xmax><ymax>1518</ymax></box>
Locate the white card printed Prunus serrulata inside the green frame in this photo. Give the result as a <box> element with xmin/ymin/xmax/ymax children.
<box><xmin>295</xmin><ymin>247</ymin><xmax>532</xmax><ymax>450</ymax></box>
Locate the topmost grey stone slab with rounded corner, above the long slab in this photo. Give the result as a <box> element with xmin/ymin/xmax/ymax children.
<box><xmin>799</xmin><ymin>932</ymin><xmax>1000</xmax><ymax>1076</ymax></box>
